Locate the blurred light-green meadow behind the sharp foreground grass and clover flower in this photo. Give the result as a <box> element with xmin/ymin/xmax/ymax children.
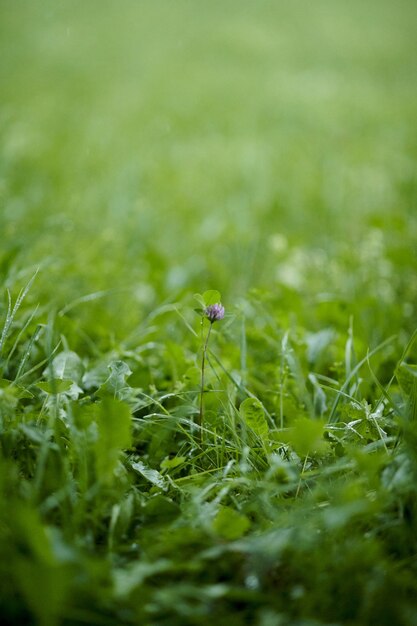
<box><xmin>0</xmin><ymin>0</ymin><xmax>417</xmax><ymax>336</ymax></box>
